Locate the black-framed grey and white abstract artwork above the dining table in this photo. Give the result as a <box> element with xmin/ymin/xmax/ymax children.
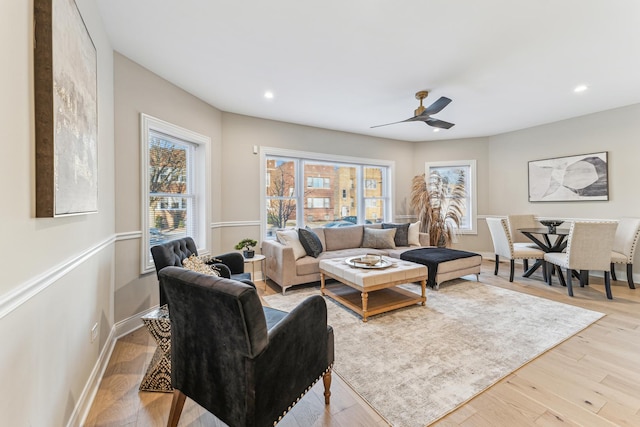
<box><xmin>529</xmin><ymin>151</ymin><xmax>609</xmax><ymax>202</ymax></box>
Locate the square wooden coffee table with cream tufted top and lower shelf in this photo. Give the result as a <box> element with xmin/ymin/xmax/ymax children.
<box><xmin>320</xmin><ymin>257</ymin><xmax>427</xmax><ymax>322</ymax></box>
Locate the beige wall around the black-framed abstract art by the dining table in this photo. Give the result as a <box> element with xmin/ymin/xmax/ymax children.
<box><xmin>414</xmin><ymin>104</ymin><xmax>640</xmax><ymax>260</ymax></box>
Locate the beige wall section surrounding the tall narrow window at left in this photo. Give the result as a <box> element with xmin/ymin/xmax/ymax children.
<box><xmin>114</xmin><ymin>53</ymin><xmax>222</xmax><ymax>321</ymax></box>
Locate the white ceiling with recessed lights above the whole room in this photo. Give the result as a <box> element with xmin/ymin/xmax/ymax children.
<box><xmin>96</xmin><ymin>0</ymin><xmax>640</xmax><ymax>141</ymax></box>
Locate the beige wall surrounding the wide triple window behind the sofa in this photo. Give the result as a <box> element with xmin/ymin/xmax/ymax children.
<box><xmin>221</xmin><ymin>113</ymin><xmax>413</xmax><ymax>251</ymax></box>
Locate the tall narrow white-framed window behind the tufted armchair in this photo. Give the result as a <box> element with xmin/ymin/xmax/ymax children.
<box><xmin>140</xmin><ymin>114</ymin><xmax>210</xmax><ymax>273</ymax></box>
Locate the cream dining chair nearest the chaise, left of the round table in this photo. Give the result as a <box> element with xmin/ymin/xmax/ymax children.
<box><xmin>487</xmin><ymin>218</ymin><xmax>546</xmax><ymax>282</ymax></box>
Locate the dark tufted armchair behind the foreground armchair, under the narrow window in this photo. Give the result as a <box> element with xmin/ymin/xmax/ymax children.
<box><xmin>151</xmin><ymin>237</ymin><xmax>251</xmax><ymax>307</ymax></box>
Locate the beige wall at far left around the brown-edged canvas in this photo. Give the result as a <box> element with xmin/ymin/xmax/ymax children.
<box><xmin>0</xmin><ymin>0</ymin><xmax>115</xmax><ymax>426</ymax></box>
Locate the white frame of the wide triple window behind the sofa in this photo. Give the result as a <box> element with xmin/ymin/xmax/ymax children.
<box><xmin>260</xmin><ymin>146</ymin><xmax>396</xmax><ymax>240</ymax></box>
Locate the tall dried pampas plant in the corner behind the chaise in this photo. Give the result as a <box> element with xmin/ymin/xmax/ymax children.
<box><xmin>410</xmin><ymin>171</ymin><xmax>466</xmax><ymax>247</ymax></box>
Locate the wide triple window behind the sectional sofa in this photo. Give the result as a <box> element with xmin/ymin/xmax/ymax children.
<box><xmin>261</xmin><ymin>148</ymin><xmax>393</xmax><ymax>239</ymax></box>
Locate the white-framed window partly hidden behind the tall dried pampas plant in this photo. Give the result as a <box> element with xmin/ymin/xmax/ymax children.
<box><xmin>425</xmin><ymin>160</ymin><xmax>477</xmax><ymax>234</ymax></box>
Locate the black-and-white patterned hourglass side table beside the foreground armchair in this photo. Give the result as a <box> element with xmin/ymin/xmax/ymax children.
<box><xmin>139</xmin><ymin>305</ymin><xmax>173</xmax><ymax>393</ymax></box>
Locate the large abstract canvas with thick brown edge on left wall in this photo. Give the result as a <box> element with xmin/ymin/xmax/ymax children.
<box><xmin>34</xmin><ymin>0</ymin><xmax>98</xmax><ymax>218</ymax></box>
